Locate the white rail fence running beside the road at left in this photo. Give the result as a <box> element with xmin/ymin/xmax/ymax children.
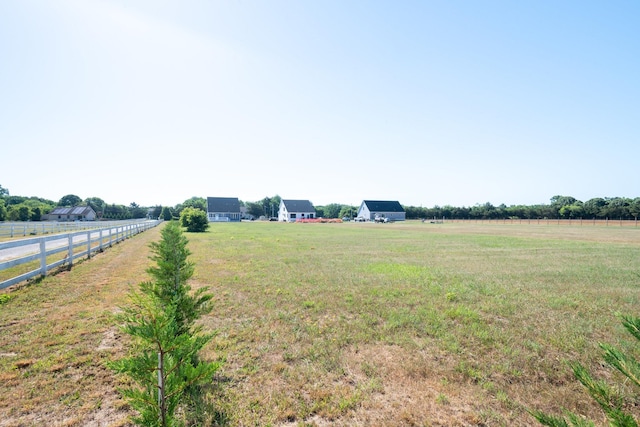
<box><xmin>0</xmin><ymin>221</ymin><xmax>161</xmax><ymax>289</ymax></box>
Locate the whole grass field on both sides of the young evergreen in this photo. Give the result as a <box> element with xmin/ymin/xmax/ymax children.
<box><xmin>0</xmin><ymin>222</ymin><xmax>640</xmax><ymax>426</ymax></box>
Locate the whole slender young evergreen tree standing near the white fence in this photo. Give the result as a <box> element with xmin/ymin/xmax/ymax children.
<box><xmin>109</xmin><ymin>222</ymin><xmax>220</xmax><ymax>427</ymax></box>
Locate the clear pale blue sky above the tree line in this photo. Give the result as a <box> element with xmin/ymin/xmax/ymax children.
<box><xmin>0</xmin><ymin>0</ymin><xmax>640</xmax><ymax>207</ymax></box>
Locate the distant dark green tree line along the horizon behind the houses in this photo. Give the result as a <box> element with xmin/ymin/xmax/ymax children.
<box><xmin>0</xmin><ymin>186</ymin><xmax>640</xmax><ymax>221</ymax></box>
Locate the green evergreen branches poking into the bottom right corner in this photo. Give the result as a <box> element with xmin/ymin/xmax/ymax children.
<box><xmin>530</xmin><ymin>316</ymin><xmax>640</xmax><ymax>427</ymax></box>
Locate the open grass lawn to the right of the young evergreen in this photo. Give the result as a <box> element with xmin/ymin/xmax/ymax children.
<box><xmin>189</xmin><ymin>222</ymin><xmax>640</xmax><ymax>425</ymax></box>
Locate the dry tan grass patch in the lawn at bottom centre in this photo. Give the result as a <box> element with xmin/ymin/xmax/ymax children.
<box><xmin>340</xmin><ymin>345</ymin><xmax>482</xmax><ymax>426</ymax></box>
